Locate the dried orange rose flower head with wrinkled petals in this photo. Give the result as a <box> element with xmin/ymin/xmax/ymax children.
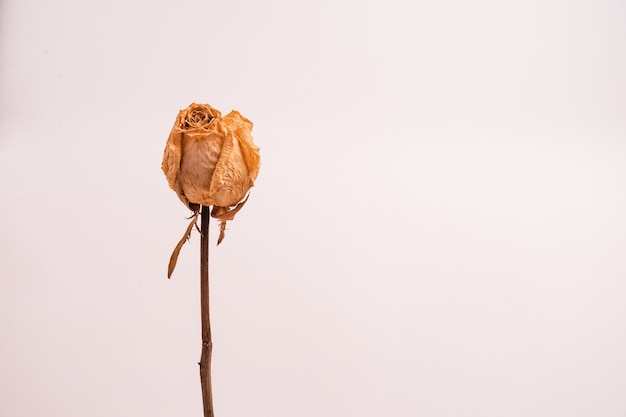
<box><xmin>161</xmin><ymin>103</ymin><xmax>261</xmax><ymax>244</ymax></box>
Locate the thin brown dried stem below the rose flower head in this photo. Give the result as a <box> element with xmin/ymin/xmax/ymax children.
<box><xmin>198</xmin><ymin>206</ymin><xmax>214</xmax><ymax>417</ymax></box>
